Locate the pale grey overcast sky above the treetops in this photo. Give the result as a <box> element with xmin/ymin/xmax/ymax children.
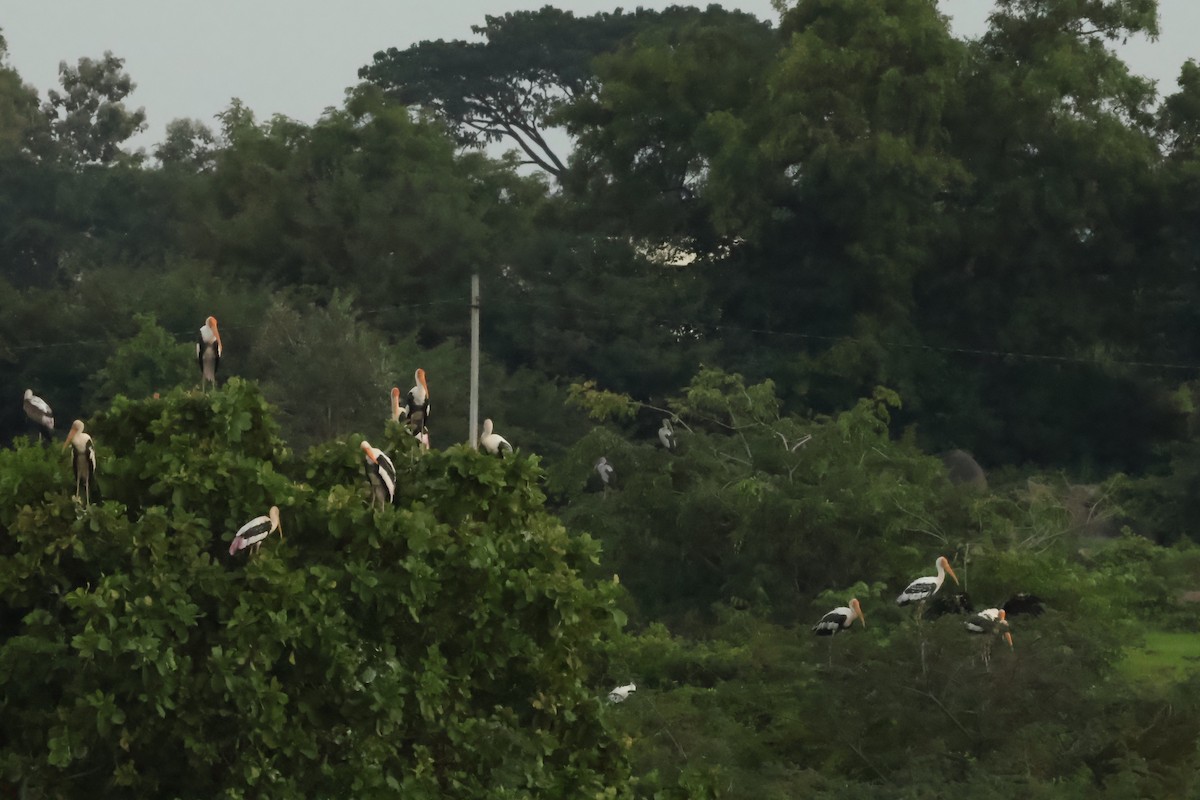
<box><xmin>0</xmin><ymin>0</ymin><xmax>1200</xmax><ymax>146</ymax></box>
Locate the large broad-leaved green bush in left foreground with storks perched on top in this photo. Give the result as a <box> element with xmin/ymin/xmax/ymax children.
<box><xmin>0</xmin><ymin>379</ymin><xmax>625</xmax><ymax>798</ymax></box>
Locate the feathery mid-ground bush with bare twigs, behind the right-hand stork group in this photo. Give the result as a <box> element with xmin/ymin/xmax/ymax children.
<box><xmin>551</xmin><ymin>368</ymin><xmax>971</xmax><ymax>620</ymax></box>
